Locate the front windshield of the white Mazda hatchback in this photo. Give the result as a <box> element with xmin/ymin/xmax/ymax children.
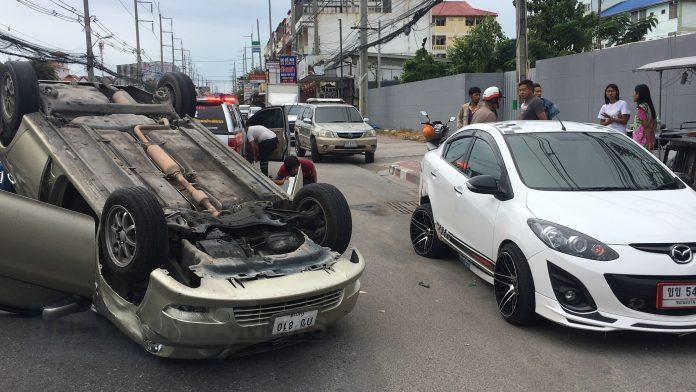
<box><xmin>505</xmin><ymin>132</ymin><xmax>683</xmax><ymax>191</ymax></box>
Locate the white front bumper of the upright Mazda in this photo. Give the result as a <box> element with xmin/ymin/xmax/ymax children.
<box><xmin>529</xmin><ymin>245</ymin><xmax>696</xmax><ymax>333</ymax></box>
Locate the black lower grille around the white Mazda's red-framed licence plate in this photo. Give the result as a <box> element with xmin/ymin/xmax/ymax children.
<box><xmin>604</xmin><ymin>274</ymin><xmax>696</xmax><ymax>316</ymax></box>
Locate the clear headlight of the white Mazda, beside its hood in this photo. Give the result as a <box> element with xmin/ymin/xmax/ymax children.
<box><xmin>527</xmin><ymin>219</ymin><xmax>619</xmax><ymax>261</ymax></box>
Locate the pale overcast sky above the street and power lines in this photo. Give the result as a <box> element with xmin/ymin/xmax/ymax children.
<box><xmin>0</xmin><ymin>0</ymin><xmax>515</xmax><ymax>91</ymax></box>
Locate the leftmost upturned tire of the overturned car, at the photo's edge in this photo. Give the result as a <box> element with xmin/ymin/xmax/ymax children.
<box><xmin>0</xmin><ymin>61</ymin><xmax>40</xmax><ymax>146</ymax></box>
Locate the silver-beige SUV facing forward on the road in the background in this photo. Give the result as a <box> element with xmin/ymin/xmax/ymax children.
<box><xmin>295</xmin><ymin>101</ymin><xmax>377</xmax><ymax>163</ymax></box>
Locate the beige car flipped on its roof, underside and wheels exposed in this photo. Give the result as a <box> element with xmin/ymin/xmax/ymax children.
<box><xmin>0</xmin><ymin>62</ymin><xmax>365</xmax><ymax>358</ymax></box>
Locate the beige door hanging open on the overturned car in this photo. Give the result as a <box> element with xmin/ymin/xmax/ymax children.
<box><xmin>0</xmin><ymin>191</ymin><xmax>97</xmax><ymax>311</ymax></box>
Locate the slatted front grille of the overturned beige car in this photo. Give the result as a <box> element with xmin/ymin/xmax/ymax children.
<box><xmin>234</xmin><ymin>290</ymin><xmax>343</xmax><ymax>327</ymax></box>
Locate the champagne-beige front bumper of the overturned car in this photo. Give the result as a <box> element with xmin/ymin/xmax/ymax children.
<box><xmin>95</xmin><ymin>250</ymin><xmax>365</xmax><ymax>359</ymax></box>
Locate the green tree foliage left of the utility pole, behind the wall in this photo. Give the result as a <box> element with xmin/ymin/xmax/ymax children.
<box><xmin>447</xmin><ymin>17</ymin><xmax>515</xmax><ymax>74</ymax></box>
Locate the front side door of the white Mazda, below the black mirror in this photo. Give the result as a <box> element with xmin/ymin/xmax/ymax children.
<box><xmin>454</xmin><ymin>131</ymin><xmax>506</xmax><ymax>268</ymax></box>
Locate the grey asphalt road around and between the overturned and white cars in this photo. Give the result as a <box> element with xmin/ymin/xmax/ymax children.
<box><xmin>0</xmin><ymin>136</ymin><xmax>696</xmax><ymax>391</ymax></box>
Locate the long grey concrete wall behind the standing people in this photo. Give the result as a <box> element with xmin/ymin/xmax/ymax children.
<box><xmin>368</xmin><ymin>34</ymin><xmax>696</xmax><ymax>129</ymax></box>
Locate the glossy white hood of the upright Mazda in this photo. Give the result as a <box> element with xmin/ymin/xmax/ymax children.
<box><xmin>527</xmin><ymin>188</ymin><xmax>696</xmax><ymax>244</ymax></box>
